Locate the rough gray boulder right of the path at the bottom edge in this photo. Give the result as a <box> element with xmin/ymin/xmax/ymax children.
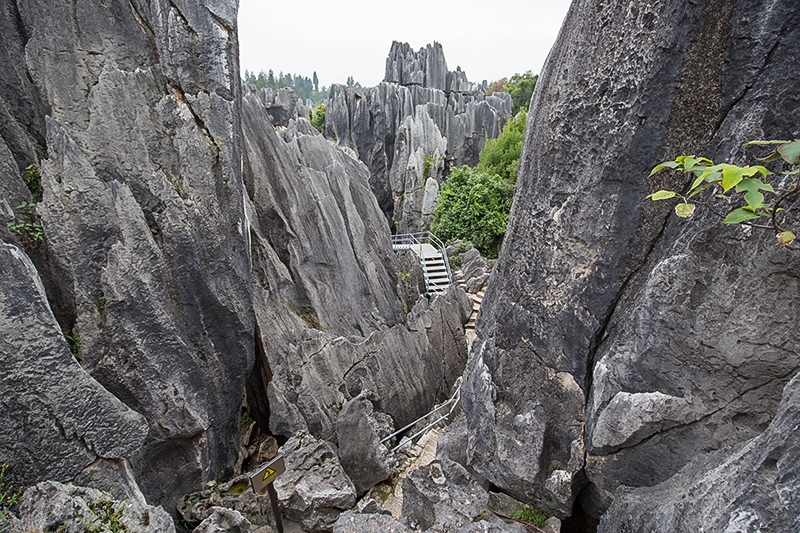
<box><xmin>402</xmin><ymin>459</ymin><xmax>489</xmax><ymax>532</ymax></box>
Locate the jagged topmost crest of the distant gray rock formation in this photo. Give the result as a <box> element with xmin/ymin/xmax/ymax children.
<box><xmin>383</xmin><ymin>41</ymin><xmax>482</xmax><ymax>93</ymax></box>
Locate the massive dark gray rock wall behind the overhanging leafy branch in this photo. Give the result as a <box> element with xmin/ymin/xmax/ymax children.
<box><xmin>462</xmin><ymin>0</ymin><xmax>800</xmax><ymax>529</ymax></box>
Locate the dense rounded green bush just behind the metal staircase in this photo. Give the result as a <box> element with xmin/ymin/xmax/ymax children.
<box><xmin>431</xmin><ymin>165</ymin><xmax>514</xmax><ymax>258</ymax></box>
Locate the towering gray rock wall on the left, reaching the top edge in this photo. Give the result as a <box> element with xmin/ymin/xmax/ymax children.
<box><xmin>0</xmin><ymin>0</ymin><xmax>254</xmax><ymax>507</ymax></box>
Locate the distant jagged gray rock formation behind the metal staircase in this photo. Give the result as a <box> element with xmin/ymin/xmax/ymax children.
<box><xmin>325</xmin><ymin>42</ymin><xmax>511</xmax><ymax>233</ymax></box>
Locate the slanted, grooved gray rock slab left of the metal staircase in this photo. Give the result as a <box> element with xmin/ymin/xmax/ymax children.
<box><xmin>242</xmin><ymin>90</ymin><xmax>469</xmax><ymax>442</ymax></box>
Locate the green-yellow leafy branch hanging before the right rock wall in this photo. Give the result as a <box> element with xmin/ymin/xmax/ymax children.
<box><xmin>648</xmin><ymin>140</ymin><xmax>800</xmax><ymax>250</ymax></box>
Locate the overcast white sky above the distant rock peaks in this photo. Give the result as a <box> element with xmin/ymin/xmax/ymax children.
<box><xmin>239</xmin><ymin>0</ymin><xmax>571</xmax><ymax>87</ymax></box>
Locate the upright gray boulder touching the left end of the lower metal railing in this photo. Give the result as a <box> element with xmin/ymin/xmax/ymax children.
<box><xmin>336</xmin><ymin>391</ymin><xmax>394</xmax><ymax>496</ymax></box>
